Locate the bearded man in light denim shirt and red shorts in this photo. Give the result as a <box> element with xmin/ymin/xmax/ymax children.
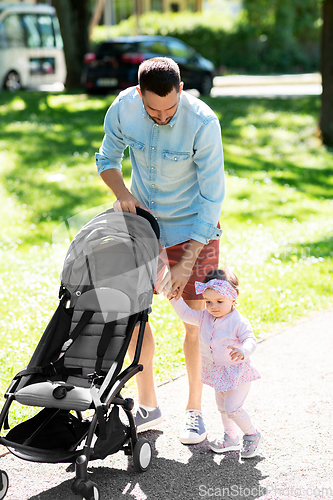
<box><xmin>96</xmin><ymin>58</ymin><xmax>224</xmax><ymax>444</ymax></box>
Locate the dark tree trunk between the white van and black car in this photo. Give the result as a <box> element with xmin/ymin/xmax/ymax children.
<box><xmin>53</xmin><ymin>0</ymin><xmax>90</xmax><ymax>89</ymax></box>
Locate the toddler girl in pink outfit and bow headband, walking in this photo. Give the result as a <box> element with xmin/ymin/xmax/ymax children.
<box><xmin>170</xmin><ymin>269</ymin><xmax>262</xmax><ymax>458</ymax></box>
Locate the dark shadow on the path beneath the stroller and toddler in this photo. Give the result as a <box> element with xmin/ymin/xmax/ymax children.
<box><xmin>29</xmin><ymin>431</ymin><xmax>266</xmax><ymax>500</ymax></box>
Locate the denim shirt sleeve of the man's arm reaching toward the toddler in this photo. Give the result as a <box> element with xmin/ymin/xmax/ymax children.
<box><xmin>191</xmin><ymin>118</ymin><xmax>225</xmax><ymax>245</ymax></box>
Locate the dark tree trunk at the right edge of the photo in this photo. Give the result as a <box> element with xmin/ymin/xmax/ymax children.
<box><xmin>319</xmin><ymin>0</ymin><xmax>333</xmax><ymax>146</ymax></box>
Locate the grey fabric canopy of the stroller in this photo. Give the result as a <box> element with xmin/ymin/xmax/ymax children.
<box><xmin>61</xmin><ymin>209</ymin><xmax>159</xmax><ymax>313</ymax></box>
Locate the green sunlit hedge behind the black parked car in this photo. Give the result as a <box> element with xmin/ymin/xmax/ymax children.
<box><xmin>92</xmin><ymin>11</ymin><xmax>320</xmax><ymax>74</ymax></box>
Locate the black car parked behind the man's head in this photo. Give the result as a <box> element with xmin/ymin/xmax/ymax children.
<box><xmin>82</xmin><ymin>35</ymin><xmax>214</xmax><ymax>94</ymax></box>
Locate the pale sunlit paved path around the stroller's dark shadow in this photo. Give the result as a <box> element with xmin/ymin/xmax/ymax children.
<box><xmin>0</xmin><ymin>310</ymin><xmax>333</xmax><ymax>500</ymax></box>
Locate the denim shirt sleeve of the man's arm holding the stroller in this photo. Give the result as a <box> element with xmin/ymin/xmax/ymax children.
<box><xmin>95</xmin><ymin>99</ymin><xmax>127</xmax><ymax>174</ymax></box>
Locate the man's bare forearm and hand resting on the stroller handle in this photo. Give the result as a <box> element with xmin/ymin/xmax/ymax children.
<box><xmin>101</xmin><ymin>168</ymin><xmax>145</xmax><ymax>214</ymax></box>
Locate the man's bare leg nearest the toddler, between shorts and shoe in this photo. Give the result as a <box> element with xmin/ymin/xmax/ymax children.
<box><xmin>184</xmin><ymin>300</ymin><xmax>205</xmax><ymax>411</ymax></box>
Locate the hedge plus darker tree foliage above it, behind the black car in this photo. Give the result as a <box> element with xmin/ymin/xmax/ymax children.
<box><xmin>93</xmin><ymin>7</ymin><xmax>320</xmax><ymax>73</ymax></box>
